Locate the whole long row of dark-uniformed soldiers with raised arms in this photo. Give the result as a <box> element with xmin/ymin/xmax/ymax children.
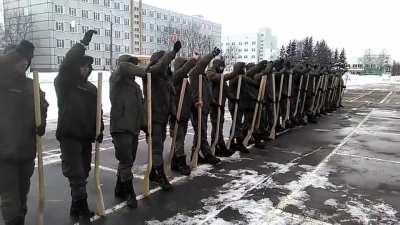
<box><xmin>0</xmin><ymin>30</ymin><xmax>345</xmax><ymax>225</ymax></box>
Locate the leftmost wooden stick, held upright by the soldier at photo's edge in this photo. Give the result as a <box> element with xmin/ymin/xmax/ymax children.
<box><xmin>33</xmin><ymin>72</ymin><xmax>45</xmax><ymax>225</ymax></box>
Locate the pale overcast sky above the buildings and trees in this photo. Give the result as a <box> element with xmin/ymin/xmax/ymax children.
<box><xmin>143</xmin><ymin>0</ymin><xmax>400</xmax><ymax>60</ymax></box>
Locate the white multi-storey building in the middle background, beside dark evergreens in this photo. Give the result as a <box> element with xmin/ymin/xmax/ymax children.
<box><xmin>222</xmin><ymin>28</ymin><xmax>278</xmax><ymax>64</ymax></box>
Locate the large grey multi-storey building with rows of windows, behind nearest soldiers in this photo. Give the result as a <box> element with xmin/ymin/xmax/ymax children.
<box><xmin>4</xmin><ymin>0</ymin><xmax>221</xmax><ymax>71</ymax></box>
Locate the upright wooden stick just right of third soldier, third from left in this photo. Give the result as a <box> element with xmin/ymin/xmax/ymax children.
<box><xmin>143</xmin><ymin>73</ymin><xmax>153</xmax><ymax>197</ymax></box>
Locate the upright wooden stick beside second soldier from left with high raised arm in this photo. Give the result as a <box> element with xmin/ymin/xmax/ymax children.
<box><xmin>94</xmin><ymin>72</ymin><xmax>105</xmax><ymax>216</ymax></box>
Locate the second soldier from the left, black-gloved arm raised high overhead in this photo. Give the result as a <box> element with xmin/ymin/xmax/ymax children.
<box><xmin>54</xmin><ymin>30</ymin><xmax>104</xmax><ymax>220</ymax></box>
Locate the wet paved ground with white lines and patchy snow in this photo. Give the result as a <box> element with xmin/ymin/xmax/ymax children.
<box><xmin>0</xmin><ymin>80</ymin><xmax>400</xmax><ymax>225</ymax></box>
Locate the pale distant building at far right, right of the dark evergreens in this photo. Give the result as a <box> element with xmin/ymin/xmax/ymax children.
<box><xmin>348</xmin><ymin>49</ymin><xmax>393</xmax><ymax>75</ymax></box>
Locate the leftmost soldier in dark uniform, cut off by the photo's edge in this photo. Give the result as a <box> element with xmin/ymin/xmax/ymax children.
<box><xmin>0</xmin><ymin>41</ymin><xmax>48</xmax><ymax>225</ymax></box>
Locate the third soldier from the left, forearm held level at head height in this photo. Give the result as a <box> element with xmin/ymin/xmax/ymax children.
<box><xmin>110</xmin><ymin>55</ymin><xmax>146</xmax><ymax>208</ymax></box>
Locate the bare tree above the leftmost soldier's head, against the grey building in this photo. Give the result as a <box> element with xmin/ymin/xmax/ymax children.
<box><xmin>4</xmin><ymin>11</ymin><xmax>32</xmax><ymax>45</ymax></box>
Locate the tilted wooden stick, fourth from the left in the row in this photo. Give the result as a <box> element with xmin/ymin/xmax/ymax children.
<box><xmin>165</xmin><ymin>78</ymin><xmax>188</xmax><ymax>177</ymax></box>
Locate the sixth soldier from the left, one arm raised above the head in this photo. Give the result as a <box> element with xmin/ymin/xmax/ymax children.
<box><xmin>189</xmin><ymin>48</ymin><xmax>221</xmax><ymax>165</ymax></box>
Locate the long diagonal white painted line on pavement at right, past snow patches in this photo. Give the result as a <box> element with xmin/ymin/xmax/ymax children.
<box><xmin>277</xmin><ymin>109</ymin><xmax>374</xmax><ymax>209</ymax></box>
